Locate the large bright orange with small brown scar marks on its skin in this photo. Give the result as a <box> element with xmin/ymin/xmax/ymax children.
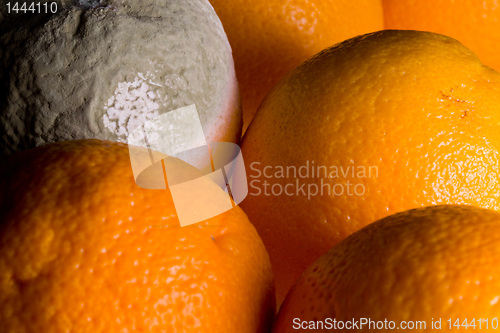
<box><xmin>240</xmin><ymin>30</ymin><xmax>500</xmax><ymax>303</ymax></box>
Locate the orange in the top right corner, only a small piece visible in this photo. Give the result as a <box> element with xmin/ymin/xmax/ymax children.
<box><xmin>383</xmin><ymin>0</ymin><xmax>500</xmax><ymax>71</ymax></box>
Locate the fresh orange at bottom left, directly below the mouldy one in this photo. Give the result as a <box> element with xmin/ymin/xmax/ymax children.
<box><xmin>0</xmin><ymin>140</ymin><xmax>275</xmax><ymax>333</ymax></box>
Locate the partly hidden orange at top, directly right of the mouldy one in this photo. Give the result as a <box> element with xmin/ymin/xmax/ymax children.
<box><xmin>210</xmin><ymin>0</ymin><xmax>384</xmax><ymax>131</ymax></box>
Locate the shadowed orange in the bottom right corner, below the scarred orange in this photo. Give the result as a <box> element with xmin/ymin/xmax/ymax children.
<box><xmin>273</xmin><ymin>206</ymin><xmax>500</xmax><ymax>333</ymax></box>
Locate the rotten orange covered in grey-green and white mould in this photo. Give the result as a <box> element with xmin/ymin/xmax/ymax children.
<box><xmin>0</xmin><ymin>0</ymin><xmax>242</xmax><ymax>170</ymax></box>
